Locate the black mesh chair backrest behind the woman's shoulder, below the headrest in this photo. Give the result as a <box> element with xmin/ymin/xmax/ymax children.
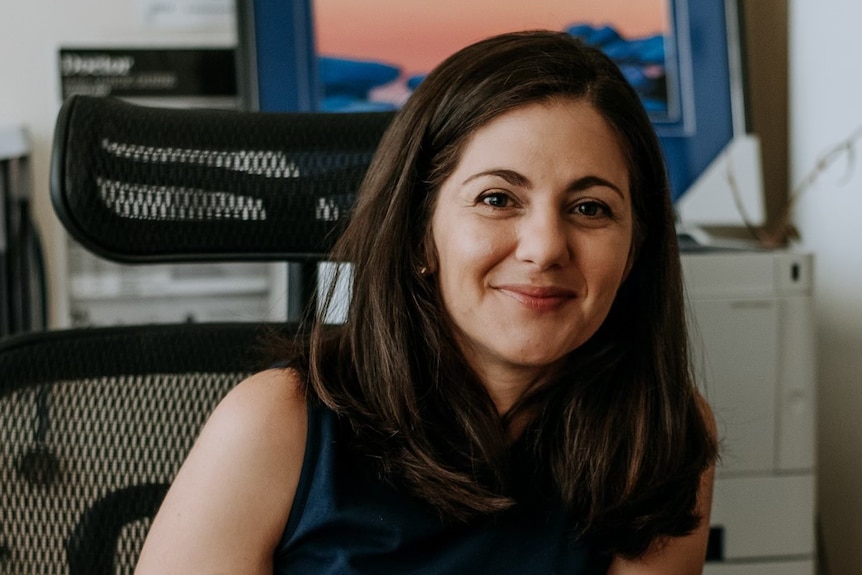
<box><xmin>0</xmin><ymin>324</ymin><xmax>291</xmax><ymax>575</ymax></box>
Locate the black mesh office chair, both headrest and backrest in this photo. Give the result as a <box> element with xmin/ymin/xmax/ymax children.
<box><xmin>0</xmin><ymin>97</ymin><xmax>392</xmax><ymax>575</ymax></box>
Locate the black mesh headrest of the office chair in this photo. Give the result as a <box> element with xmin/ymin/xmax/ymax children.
<box><xmin>51</xmin><ymin>96</ymin><xmax>393</xmax><ymax>261</ymax></box>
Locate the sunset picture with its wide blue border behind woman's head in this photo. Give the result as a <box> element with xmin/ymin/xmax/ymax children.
<box><xmin>239</xmin><ymin>0</ymin><xmax>744</xmax><ymax>209</ymax></box>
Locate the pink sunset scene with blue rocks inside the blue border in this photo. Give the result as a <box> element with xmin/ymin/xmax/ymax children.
<box><xmin>312</xmin><ymin>0</ymin><xmax>672</xmax><ymax>114</ymax></box>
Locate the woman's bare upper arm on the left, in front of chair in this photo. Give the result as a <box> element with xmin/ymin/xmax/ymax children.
<box><xmin>135</xmin><ymin>369</ymin><xmax>307</xmax><ymax>575</ymax></box>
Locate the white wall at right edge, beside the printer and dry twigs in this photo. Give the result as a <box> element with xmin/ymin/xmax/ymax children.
<box><xmin>789</xmin><ymin>0</ymin><xmax>862</xmax><ymax>575</ymax></box>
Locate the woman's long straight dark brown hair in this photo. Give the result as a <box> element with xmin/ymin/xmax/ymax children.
<box><xmin>296</xmin><ymin>31</ymin><xmax>716</xmax><ymax>556</ymax></box>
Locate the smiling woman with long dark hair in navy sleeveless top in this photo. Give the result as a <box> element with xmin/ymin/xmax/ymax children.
<box><xmin>133</xmin><ymin>32</ymin><xmax>716</xmax><ymax>575</ymax></box>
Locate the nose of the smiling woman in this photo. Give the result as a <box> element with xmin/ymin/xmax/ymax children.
<box><xmin>515</xmin><ymin>210</ymin><xmax>571</xmax><ymax>269</ymax></box>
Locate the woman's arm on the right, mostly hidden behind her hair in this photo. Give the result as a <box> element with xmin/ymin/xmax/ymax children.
<box><xmin>608</xmin><ymin>398</ymin><xmax>718</xmax><ymax>575</ymax></box>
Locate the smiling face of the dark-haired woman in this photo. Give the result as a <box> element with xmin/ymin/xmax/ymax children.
<box><xmin>431</xmin><ymin>98</ymin><xmax>633</xmax><ymax>409</ymax></box>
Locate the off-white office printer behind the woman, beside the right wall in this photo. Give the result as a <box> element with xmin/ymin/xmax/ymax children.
<box><xmin>682</xmin><ymin>250</ymin><xmax>816</xmax><ymax>575</ymax></box>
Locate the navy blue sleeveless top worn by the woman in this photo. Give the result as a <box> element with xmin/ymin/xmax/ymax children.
<box><xmin>274</xmin><ymin>402</ymin><xmax>608</xmax><ymax>575</ymax></box>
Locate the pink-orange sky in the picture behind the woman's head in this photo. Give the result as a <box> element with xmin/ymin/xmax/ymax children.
<box><xmin>313</xmin><ymin>0</ymin><xmax>670</xmax><ymax>75</ymax></box>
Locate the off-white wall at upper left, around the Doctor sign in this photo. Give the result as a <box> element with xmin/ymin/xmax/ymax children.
<box><xmin>0</xmin><ymin>0</ymin><xmax>236</xmax><ymax>327</ymax></box>
